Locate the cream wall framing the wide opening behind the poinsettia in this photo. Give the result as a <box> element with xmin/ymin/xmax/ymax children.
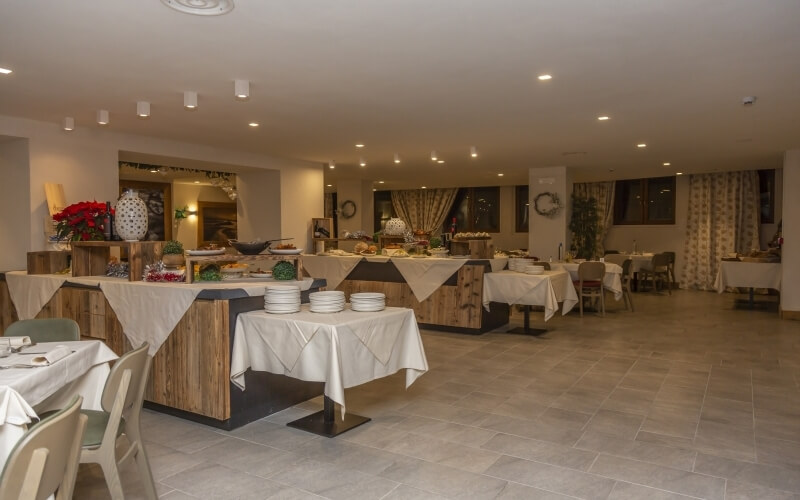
<box><xmin>0</xmin><ymin>115</ymin><xmax>323</xmax><ymax>266</ymax></box>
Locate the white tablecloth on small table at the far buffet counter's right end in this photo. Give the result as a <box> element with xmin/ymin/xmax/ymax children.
<box><xmin>483</xmin><ymin>269</ymin><xmax>578</xmax><ymax>321</ymax></box>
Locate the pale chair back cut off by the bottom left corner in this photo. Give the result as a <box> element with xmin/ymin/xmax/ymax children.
<box><xmin>0</xmin><ymin>396</ymin><xmax>87</xmax><ymax>500</ymax></box>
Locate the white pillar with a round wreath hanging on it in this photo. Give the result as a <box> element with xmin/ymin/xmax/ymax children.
<box><xmin>528</xmin><ymin>167</ymin><xmax>572</xmax><ymax>260</ymax></box>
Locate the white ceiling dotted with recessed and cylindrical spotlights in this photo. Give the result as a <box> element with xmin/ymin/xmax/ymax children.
<box><xmin>0</xmin><ymin>0</ymin><xmax>800</xmax><ymax>187</ymax></box>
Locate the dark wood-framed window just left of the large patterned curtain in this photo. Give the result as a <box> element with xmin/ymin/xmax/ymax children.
<box><xmin>614</xmin><ymin>177</ymin><xmax>675</xmax><ymax>225</ymax></box>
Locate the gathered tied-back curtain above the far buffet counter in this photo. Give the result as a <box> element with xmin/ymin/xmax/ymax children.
<box><xmin>392</xmin><ymin>188</ymin><xmax>458</xmax><ymax>234</ymax></box>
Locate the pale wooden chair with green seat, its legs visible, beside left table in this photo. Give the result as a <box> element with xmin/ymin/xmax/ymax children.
<box><xmin>39</xmin><ymin>342</ymin><xmax>158</xmax><ymax>500</ymax></box>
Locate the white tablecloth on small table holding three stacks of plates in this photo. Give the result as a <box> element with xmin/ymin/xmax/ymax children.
<box><xmin>231</xmin><ymin>305</ymin><xmax>428</xmax><ymax>413</ymax></box>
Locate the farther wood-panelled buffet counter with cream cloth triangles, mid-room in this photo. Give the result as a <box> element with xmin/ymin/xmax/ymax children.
<box><xmin>303</xmin><ymin>255</ymin><xmax>509</xmax><ymax>334</ymax></box>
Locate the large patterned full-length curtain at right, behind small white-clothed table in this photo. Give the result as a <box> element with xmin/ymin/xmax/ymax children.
<box><xmin>681</xmin><ymin>170</ymin><xmax>760</xmax><ymax>290</ymax></box>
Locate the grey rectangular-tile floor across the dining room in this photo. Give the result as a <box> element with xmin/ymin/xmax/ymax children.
<box><xmin>76</xmin><ymin>291</ymin><xmax>800</xmax><ymax>500</ymax></box>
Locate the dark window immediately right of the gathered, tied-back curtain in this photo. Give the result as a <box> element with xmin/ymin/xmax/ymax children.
<box><xmin>445</xmin><ymin>186</ymin><xmax>500</xmax><ymax>233</ymax></box>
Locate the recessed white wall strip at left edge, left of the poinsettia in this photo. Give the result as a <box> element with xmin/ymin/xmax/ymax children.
<box><xmin>0</xmin><ymin>137</ymin><xmax>30</xmax><ymax>270</ymax></box>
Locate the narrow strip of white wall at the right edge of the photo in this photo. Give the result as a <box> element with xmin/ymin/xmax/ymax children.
<box><xmin>781</xmin><ymin>149</ymin><xmax>800</xmax><ymax>319</ymax></box>
